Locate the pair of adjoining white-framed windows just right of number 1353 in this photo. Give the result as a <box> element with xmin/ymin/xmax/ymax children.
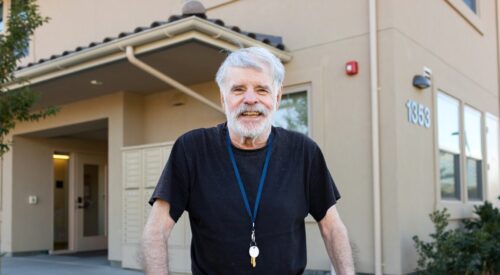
<box><xmin>437</xmin><ymin>92</ymin><xmax>484</xmax><ymax>201</ymax></box>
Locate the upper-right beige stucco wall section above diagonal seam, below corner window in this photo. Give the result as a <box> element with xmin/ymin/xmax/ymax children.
<box><xmin>394</xmin><ymin>0</ymin><xmax>498</xmax><ymax>97</ymax></box>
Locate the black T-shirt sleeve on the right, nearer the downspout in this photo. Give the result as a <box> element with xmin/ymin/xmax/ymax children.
<box><xmin>308</xmin><ymin>145</ymin><xmax>340</xmax><ymax>221</ymax></box>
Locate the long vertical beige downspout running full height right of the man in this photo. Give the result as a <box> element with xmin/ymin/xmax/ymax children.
<box><xmin>369</xmin><ymin>0</ymin><xmax>382</xmax><ymax>275</ymax></box>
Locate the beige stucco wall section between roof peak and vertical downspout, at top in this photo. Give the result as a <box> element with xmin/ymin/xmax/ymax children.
<box><xmin>207</xmin><ymin>0</ymin><xmax>368</xmax><ymax>53</ymax></box>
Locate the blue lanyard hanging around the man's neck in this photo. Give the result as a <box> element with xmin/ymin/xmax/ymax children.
<box><xmin>226</xmin><ymin>129</ymin><xmax>273</xmax><ymax>228</ymax></box>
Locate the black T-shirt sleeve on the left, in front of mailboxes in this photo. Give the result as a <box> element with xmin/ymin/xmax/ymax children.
<box><xmin>149</xmin><ymin>137</ymin><xmax>189</xmax><ymax>222</ymax></box>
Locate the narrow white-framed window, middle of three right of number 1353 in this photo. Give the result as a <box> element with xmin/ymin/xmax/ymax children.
<box><xmin>464</xmin><ymin>106</ymin><xmax>483</xmax><ymax>201</ymax></box>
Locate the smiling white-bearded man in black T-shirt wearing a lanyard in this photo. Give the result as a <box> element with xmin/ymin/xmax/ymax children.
<box><xmin>142</xmin><ymin>47</ymin><xmax>354</xmax><ymax>275</ymax></box>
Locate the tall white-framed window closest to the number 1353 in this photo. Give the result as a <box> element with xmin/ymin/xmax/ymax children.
<box><xmin>437</xmin><ymin>93</ymin><xmax>461</xmax><ymax>200</ymax></box>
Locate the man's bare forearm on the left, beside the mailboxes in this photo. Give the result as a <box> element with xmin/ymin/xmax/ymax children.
<box><xmin>142</xmin><ymin>199</ymin><xmax>175</xmax><ymax>275</ymax></box>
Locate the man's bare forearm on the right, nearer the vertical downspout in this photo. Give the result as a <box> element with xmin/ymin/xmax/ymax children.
<box><xmin>318</xmin><ymin>205</ymin><xmax>354</xmax><ymax>275</ymax></box>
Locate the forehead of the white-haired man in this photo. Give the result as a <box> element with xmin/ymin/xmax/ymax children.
<box><xmin>226</xmin><ymin>66</ymin><xmax>273</xmax><ymax>85</ymax></box>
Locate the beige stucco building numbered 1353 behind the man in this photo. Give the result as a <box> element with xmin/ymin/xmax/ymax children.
<box><xmin>0</xmin><ymin>0</ymin><xmax>500</xmax><ymax>274</ymax></box>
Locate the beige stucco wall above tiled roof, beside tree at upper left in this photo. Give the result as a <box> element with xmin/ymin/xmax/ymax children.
<box><xmin>24</xmin><ymin>0</ymin><xmax>182</xmax><ymax>65</ymax></box>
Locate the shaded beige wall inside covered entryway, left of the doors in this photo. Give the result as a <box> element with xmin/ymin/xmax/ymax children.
<box><xmin>6</xmin><ymin>138</ymin><xmax>53</xmax><ymax>251</ymax></box>
